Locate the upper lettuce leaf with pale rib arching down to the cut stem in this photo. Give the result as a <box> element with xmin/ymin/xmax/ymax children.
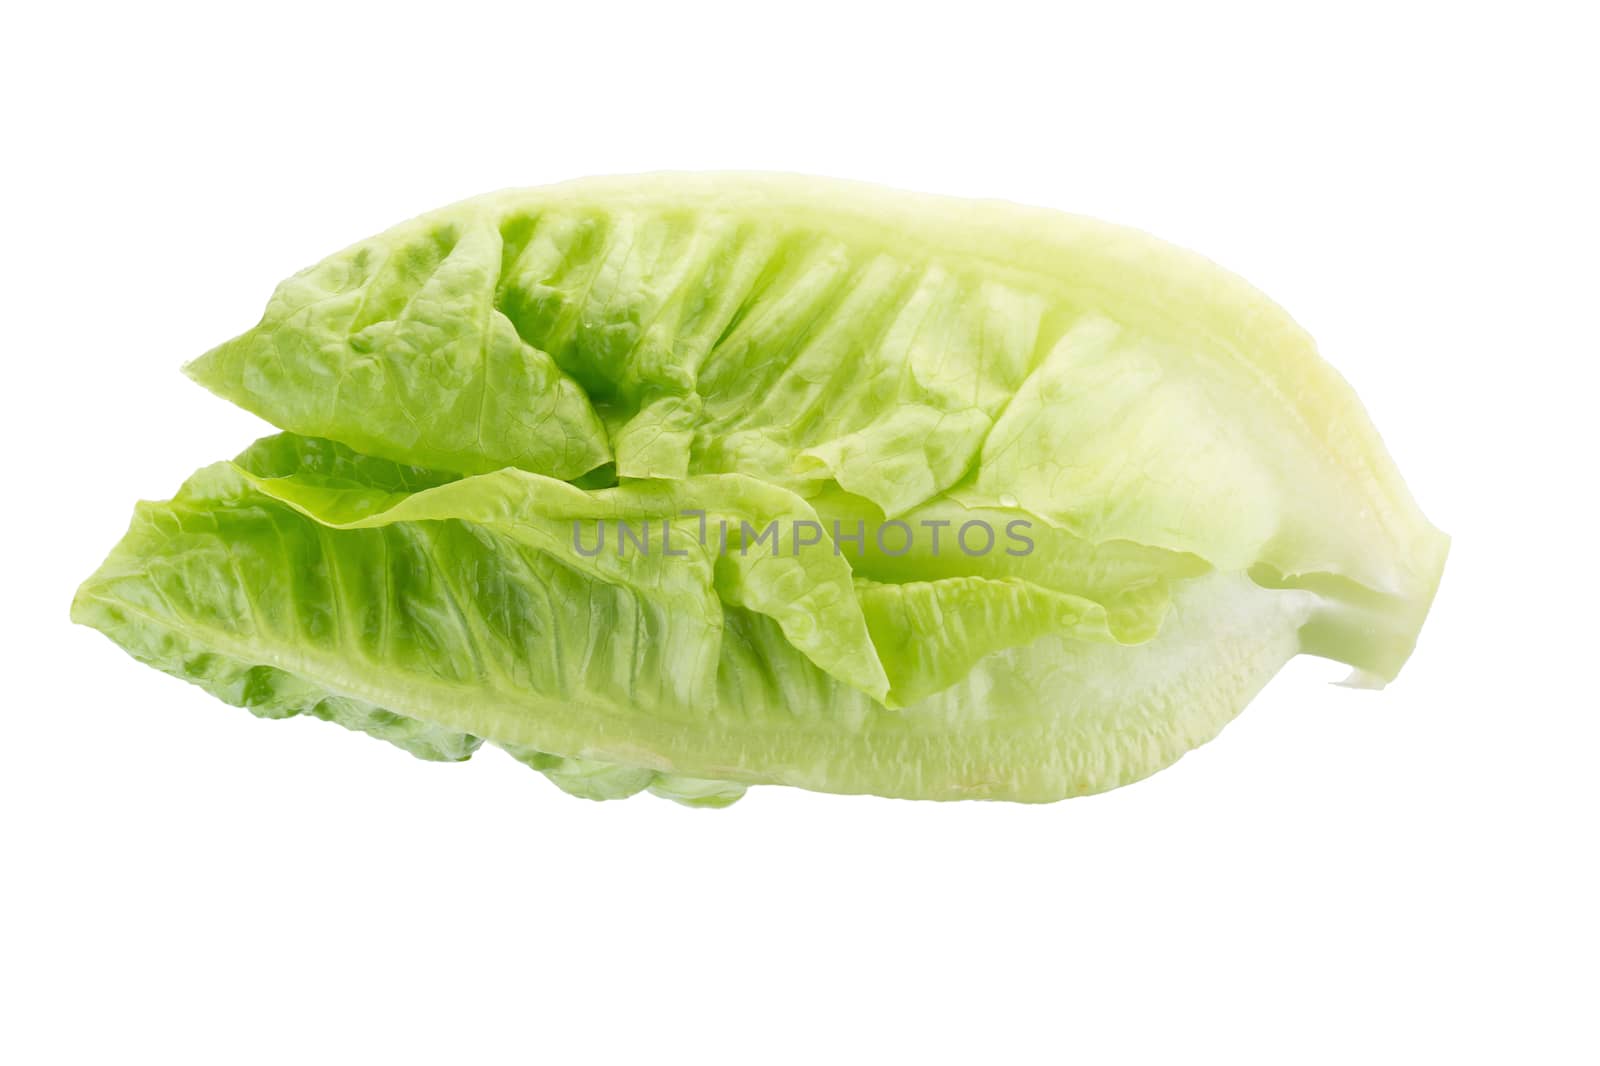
<box><xmin>187</xmin><ymin>174</ymin><xmax>1448</xmax><ymax>677</ymax></box>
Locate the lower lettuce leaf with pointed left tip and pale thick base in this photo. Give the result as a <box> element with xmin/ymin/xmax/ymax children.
<box><xmin>74</xmin><ymin>435</ymin><xmax>1337</xmax><ymax>805</ymax></box>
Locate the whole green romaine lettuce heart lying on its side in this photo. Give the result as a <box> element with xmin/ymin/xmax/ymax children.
<box><xmin>74</xmin><ymin>174</ymin><xmax>1448</xmax><ymax>807</ymax></box>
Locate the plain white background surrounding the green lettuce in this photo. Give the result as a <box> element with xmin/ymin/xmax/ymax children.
<box><xmin>0</xmin><ymin>0</ymin><xmax>1600</xmax><ymax>1063</ymax></box>
